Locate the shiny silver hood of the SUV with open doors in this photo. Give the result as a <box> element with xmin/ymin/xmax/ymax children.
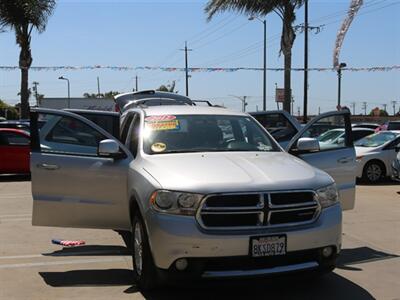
<box><xmin>143</xmin><ymin>152</ymin><xmax>333</xmax><ymax>193</ymax></box>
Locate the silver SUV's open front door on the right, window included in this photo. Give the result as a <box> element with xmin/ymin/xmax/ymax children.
<box><xmin>286</xmin><ymin>110</ymin><xmax>356</xmax><ymax>210</ymax></box>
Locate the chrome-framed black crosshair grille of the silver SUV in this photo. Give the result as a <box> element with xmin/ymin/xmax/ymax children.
<box><xmin>197</xmin><ymin>191</ymin><xmax>320</xmax><ymax>229</ymax></box>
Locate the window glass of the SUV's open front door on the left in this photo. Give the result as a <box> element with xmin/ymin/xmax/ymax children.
<box><xmin>39</xmin><ymin>114</ymin><xmax>107</xmax><ymax>156</ymax></box>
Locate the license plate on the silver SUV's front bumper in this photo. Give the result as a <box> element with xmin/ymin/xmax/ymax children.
<box><xmin>250</xmin><ymin>235</ymin><xmax>286</xmax><ymax>257</ymax></box>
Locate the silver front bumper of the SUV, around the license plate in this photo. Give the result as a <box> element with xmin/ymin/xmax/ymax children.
<box><xmin>146</xmin><ymin>204</ymin><xmax>342</xmax><ymax>277</ymax></box>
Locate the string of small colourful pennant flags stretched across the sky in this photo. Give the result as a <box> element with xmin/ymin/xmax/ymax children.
<box><xmin>0</xmin><ymin>65</ymin><xmax>400</xmax><ymax>73</ymax></box>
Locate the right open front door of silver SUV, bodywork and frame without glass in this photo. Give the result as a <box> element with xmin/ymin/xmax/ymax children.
<box><xmin>286</xmin><ymin>111</ymin><xmax>356</xmax><ymax>210</ymax></box>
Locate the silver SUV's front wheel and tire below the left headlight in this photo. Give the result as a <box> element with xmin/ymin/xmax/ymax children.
<box><xmin>132</xmin><ymin>212</ymin><xmax>160</xmax><ymax>291</ymax></box>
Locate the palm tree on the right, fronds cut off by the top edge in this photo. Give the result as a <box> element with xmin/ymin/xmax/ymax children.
<box><xmin>205</xmin><ymin>0</ymin><xmax>305</xmax><ymax>112</ymax></box>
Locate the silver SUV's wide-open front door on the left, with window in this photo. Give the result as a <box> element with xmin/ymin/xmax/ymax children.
<box><xmin>31</xmin><ymin>109</ymin><xmax>133</xmax><ymax>230</ymax></box>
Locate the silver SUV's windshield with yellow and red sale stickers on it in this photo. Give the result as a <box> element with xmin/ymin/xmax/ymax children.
<box><xmin>143</xmin><ymin>115</ymin><xmax>281</xmax><ymax>154</ymax></box>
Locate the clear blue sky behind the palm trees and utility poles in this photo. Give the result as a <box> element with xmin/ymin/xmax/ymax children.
<box><xmin>0</xmin><ymin>0</ymin><xmax>400</xmax><ymax>114</ymax></box>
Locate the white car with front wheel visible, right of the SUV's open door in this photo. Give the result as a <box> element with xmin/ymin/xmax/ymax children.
<box><xmin>355</xmin><ymin>130</ymin><xmax>400</xmax><ymax>183</ymax></box>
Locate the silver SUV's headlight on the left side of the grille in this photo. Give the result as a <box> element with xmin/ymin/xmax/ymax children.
<box><xmin>150</xmin><ymin>190</ymin><xmax>203</xmax><ymax>216</ymax></box>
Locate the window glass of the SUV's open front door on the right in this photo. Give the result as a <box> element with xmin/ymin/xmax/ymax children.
<box><xmin>290</xmin><ymin>115</ymin><xmax>353</xmax><ymax>152</ymax></box>
